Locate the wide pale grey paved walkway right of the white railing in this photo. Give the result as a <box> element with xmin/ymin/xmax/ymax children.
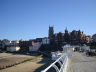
<box><xmin>68</xmin><ymin>52</ymin><xmax>96</xmax><ymax>72</ymax></box>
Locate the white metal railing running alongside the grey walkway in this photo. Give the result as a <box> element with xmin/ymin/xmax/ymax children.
<box><xmin>41</xmin><ymin>52</ymin><xmax>70</xmax><ymax>72</ymax></box>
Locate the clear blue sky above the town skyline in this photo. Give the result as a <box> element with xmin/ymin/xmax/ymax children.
<box><xmin>0</xmin><ymin>0</ymin><xmax>96</xmax><ymax>40</ymax></box>
